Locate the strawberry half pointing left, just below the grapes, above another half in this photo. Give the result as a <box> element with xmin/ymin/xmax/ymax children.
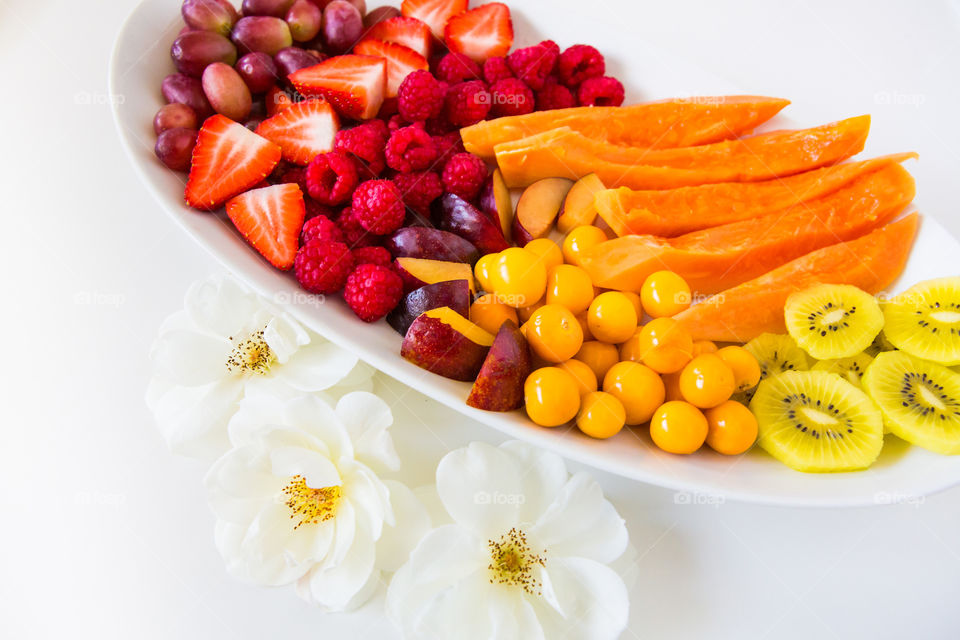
<box><xmin>288</xmin><ymin>54</ymin><xmax>387</xmax><ymax>120</ymax></box>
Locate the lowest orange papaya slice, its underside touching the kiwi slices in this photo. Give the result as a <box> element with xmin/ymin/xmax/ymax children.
<box><xmin>674</xmin><ymin>213</ymin><xmax>920</xmax><ymax>342</ymax></box>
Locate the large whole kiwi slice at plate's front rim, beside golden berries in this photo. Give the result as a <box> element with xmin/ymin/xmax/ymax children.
<box><xmin>750</xmin><ymin>371</ymin><xmax>883</xmax><ymax>473</ymax></box>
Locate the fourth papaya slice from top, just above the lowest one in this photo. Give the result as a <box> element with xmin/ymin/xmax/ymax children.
<box><xmin>581</xmin><ymin>164</ymin><xmax>916</xmax><ymax>294</ymax></box>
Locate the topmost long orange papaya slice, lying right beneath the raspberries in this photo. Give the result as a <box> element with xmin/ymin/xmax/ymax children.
<box><xmin>460</xmin><ymin>96</ymin><xmax>790</xmax><ymax>160</ymax></box>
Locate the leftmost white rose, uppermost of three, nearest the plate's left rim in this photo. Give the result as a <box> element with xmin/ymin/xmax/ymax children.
<box><xmin>147</xmin><ymin>276</ymin><xmax>373</xmax><ymax>460</ymax></box>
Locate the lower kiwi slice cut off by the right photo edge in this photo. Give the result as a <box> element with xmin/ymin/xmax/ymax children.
<box><xmin>863</xmin><ymin>351</ymin><xmax>960</xmax><ymax>455</ymax></box>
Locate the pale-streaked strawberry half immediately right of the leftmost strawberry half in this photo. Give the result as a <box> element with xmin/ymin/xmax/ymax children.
<box><xmin>257</xmin><ymin>100</ymin><xmax>340</xmax><ymax>164</ymax></box>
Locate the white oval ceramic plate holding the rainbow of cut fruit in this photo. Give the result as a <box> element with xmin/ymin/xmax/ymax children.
<box><xmin>110</xmin><ymin>0</ymin><xmax>960</xmax><ymax>506</ymax></box>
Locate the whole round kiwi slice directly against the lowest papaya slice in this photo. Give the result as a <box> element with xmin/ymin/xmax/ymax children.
<box><xmin>783</xmin><ymin>284</ymin><xmax>883</xmax><ymax>360</ymax></box>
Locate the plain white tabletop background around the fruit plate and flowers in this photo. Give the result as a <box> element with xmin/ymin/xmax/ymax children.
<box><xmin>0</xmin><ymin>0</ymin><xmax>960</xmax><ymax>639</ymax></box>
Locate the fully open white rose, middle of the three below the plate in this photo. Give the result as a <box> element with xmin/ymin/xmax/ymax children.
<box><xmin>206</xmin><ymin>391</ymin><xmax>430</xmax><ymax>611</ymax></box>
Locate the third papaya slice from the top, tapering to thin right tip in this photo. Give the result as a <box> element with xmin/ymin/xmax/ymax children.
<box><xmin>594</xmin><ymin>153</ymin><xmax>917</xmax><ymax>238</ymax></box>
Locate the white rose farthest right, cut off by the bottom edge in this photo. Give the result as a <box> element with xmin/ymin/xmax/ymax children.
<box><xmin>387</xmin><ymin>441</ymin><xmax>629</xmax><ymax>640</ymax></box>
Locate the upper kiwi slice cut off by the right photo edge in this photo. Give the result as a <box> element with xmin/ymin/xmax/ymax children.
<box><xmin>883</xmin><ymin>277</ymin><xmax>960</xmax><ymax>366</ymax></box>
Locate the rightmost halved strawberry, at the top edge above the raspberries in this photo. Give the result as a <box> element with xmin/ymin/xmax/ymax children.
<box><xmin>443</xmin><ymin>2</ymin><xmax>513</xmax><ymax>63</ymax></box>
